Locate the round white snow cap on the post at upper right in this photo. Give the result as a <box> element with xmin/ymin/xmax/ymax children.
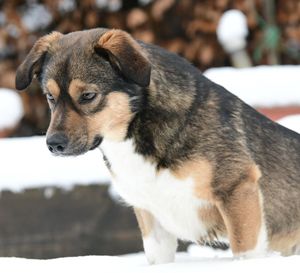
<box><xmin>217</xmin><ymin>10</ymin><xmax>248</xmax><ymax>53</ymax></box>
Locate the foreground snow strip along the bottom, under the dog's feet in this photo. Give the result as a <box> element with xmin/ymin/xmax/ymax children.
<box><xmin>0</xmin><ymin>246</ymin><xmax>300</xmax><ymax>273</ymax></box>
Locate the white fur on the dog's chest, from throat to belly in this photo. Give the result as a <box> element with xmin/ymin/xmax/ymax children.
<box><xmin>101</xmin><ymin>140</ymin><xmax>209</xmax><ymax>241</ymax></box>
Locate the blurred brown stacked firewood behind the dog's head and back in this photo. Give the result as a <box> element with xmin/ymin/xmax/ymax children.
<box><xmin>0</xmin><ymin>0</ymin><xmax>300</xmax><ymax>135</ymax></box>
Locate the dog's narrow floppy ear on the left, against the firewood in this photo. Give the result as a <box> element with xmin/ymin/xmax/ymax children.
<box><xmin>16</xmin><ymin>31</ymin><xmax>63</xmax><ymax>90</ymax></box>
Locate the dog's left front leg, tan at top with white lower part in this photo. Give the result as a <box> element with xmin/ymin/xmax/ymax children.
<box><xmin>134</xmin><ymin>208</ymin><xmax>177</xmax><ymax>264</ymax></box>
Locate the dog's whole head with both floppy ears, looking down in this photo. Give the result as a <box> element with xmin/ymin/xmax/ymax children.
<box><xmin>16</xmin><ymin>29</ymin><xmax>151</xmax><ymax>155</ymax></box>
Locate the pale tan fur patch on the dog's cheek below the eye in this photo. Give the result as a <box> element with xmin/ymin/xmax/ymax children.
<box><xmin>88</xmin><ymin>92</ymin><xmax>133</xmax><ymax>141</ymax></box>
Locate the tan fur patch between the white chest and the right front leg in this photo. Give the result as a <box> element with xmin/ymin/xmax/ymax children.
<box><xmin>172</xmin><ymin>159</ymin><xmax>214</xmax><ymax>202</ymax></box>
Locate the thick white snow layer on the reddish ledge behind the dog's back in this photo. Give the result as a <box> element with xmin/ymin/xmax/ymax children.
<box><xmin>204</xmin><ymin>65</ymin><xmax>300</xmax><ymax>107</ymax></box>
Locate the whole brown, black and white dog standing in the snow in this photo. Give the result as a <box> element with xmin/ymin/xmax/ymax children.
<box><xmin>16</xmin><ymin>28</ymin><xmax>300</xmax><ymax>264</ymax></box>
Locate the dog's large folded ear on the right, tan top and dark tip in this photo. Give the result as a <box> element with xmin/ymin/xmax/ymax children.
<box><xmin>94</xmin><ymin>29</ymin><xmax>151</xmax><ymax>87</ymax></box>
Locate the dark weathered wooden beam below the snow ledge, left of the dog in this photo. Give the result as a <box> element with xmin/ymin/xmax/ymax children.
<box><xmin>0</xmin><ymin>185</ymin><xmax>142</xmax><ymax>259</ymax></box>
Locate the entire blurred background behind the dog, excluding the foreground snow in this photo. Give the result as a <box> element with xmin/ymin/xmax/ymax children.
<box><xmin>0</xmin><ymin>0</ymin><xmax>300</xmax><ymax>258</ymax></box>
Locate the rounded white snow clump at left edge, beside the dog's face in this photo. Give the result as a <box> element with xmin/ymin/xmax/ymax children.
<box><xmin>0</xmin><ymin>88</ymin><xmax>24</xmax><ymax>130</ymax></box>
